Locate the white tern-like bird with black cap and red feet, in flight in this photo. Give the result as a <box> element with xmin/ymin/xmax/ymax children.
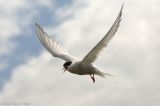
<box><xmin>36</xmin><ymin>5</ymin><xmax>123</xmax><ymax>83</ymax></box>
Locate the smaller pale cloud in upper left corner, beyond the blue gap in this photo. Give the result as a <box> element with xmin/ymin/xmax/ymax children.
<box><xmin>0</xmin><ymin>0</ymin><xmax>53</xmax><ymax>55</ymax></box>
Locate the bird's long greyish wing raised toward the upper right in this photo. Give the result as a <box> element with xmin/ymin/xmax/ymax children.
<box><xmin>82</xmin><ymin>5</ymin><xmax>123</xmax><ymax>63</ymax></box>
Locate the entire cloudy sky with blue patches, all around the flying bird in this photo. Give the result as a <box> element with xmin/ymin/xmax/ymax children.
<box><xmin>0</xmin><ymin>0</ymin><xmax>160</xmax><ymax>106</ymax></box>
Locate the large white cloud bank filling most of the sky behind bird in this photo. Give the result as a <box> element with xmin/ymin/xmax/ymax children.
<box><xmin>0</xmin><ymin>0</ymin><xmax>160</xmax><ymax>106</ymax></box>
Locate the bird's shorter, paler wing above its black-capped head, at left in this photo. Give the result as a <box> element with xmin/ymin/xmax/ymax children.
<box><xmin>36</xmin><ymin>23</ymin><xmax>76</xmax><ymax>61</ymax></box>
